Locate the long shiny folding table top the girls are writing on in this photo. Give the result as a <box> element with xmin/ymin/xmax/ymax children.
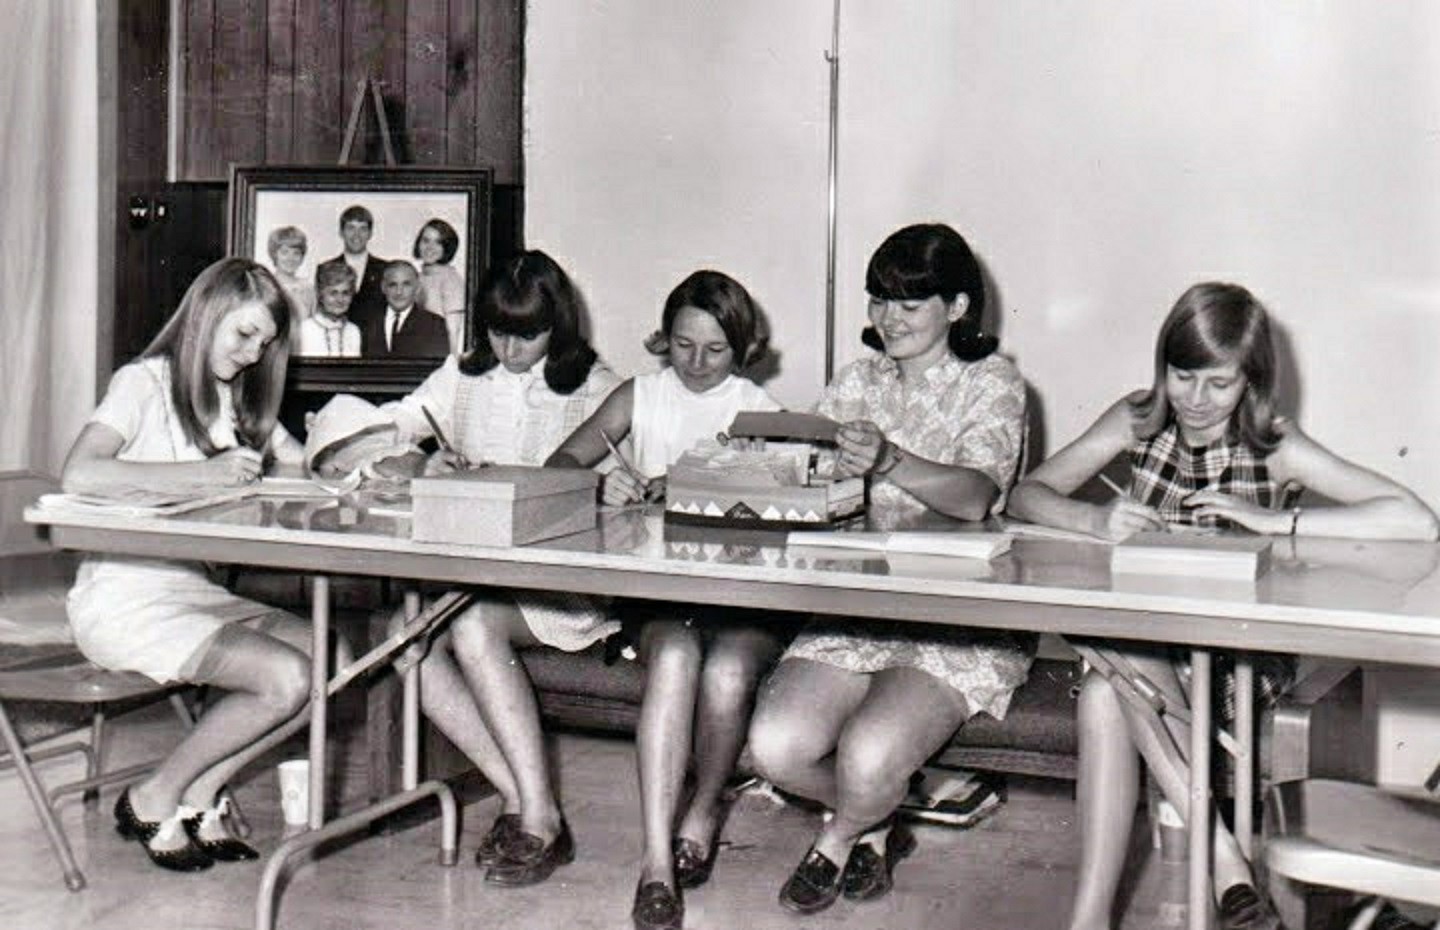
<box><xmin>26</xmin><ymin>495</ymin><xmax>1440</xmax><ymax>667</ymax></box>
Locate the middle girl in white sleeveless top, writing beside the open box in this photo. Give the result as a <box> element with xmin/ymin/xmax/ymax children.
<box><xmin>546</xmin><ymin>271</ymin><xmax>785</xmax><ymax>930</ymax></box>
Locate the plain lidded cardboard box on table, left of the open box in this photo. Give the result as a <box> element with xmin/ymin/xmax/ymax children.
<box><xmin>410</xmin><ymin>465</ymin><xmax>599</xmax><ymax>546</ymax></box>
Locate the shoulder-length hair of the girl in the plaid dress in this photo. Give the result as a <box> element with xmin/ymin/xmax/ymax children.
<box><xmin>1130</xmin><ymin>281</ymin><xmax>1280</xmax><ymax>452</ymax></box>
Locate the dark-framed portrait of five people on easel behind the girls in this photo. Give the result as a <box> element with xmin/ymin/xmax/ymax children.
<box><xmin>228</xmin><ymin>166</ymin><xmax>492</xmax><ymax>394</ymax></box>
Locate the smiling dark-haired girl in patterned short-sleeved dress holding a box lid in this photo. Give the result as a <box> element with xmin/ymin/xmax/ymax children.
<box><xmin>750</xmin><ymin>225</ymin><xmax>1034</xmax><ymax>913</ymax></box>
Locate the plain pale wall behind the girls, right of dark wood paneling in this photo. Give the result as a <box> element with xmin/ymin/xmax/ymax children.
<box><xmin>526</xmin><ymin>0</ymin><xmax>1440</xmax><ymax>504</ymax></box>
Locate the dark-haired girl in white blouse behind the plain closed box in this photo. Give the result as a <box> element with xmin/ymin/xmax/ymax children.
<box><xmin>382</xmin><ymin>252</ymin><xmax>619</xmax><ymax>885</ymax></box>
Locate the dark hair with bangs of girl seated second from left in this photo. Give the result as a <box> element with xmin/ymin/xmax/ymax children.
<box><xmin>459</xmin><ymin>249</ymin><xmax>596</xmax><ymax>394</ymax></box>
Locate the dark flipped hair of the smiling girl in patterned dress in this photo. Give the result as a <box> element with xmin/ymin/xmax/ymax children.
<box><xmin>860</xmin><ymin>223</ymin><xmax>999</xmax><ymax>361</ymax></box>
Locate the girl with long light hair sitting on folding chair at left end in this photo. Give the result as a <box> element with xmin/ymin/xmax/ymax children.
<box><xmin>63</xmin><ymin>258</ymin><xmax>348</xmax><ymax>871</ymax></box>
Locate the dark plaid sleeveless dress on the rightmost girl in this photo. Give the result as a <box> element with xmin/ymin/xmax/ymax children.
<box><xmin>1128</xmin><ymin>422</ymin><xmax>1302</xmax><ymax>721</ymax></box>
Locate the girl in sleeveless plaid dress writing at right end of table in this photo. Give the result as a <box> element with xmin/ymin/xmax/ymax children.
<box><xmin>1009</xmin><ymin>284</ymin><xmax>1437</xmax><ymax>930</ymax></box>
